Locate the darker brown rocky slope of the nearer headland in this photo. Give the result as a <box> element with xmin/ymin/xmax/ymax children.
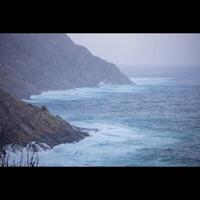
<box><xmin>0</xmin><ymin>89</ymin><xmax>89</xmax><ymax>147</ymax></box>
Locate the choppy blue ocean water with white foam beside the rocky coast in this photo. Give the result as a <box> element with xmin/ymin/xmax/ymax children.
<box><xmin>25</xmin><ymin>77</ymin><xmax>200</xmax><ymax>166</ymax></box>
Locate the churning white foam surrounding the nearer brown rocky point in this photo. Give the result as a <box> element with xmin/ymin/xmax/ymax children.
<box><xmin>36</xmin><ymin>122</ymin><xmax>175</xmax><ymax>166</ymax></box>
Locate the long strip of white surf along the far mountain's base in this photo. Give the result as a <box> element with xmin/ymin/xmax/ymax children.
<box><xmin>25</xmin><ymin>77</ymin><xmax>176</xmax><ymax>103</ymax></box>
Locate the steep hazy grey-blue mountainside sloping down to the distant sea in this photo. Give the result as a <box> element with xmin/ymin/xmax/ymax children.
<box><xmin>0</xmin><ymin>34</ymin><xmax>132</xmax><ymax>99</ymax></box>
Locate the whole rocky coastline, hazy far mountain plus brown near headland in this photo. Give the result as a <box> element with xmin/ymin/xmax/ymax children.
<box><xmin>0</xmin><ymin>34</ymin><xmax>133</xmax><ymax>154</ymax></box>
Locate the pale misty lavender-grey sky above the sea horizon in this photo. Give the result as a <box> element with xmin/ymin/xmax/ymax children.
<box><xmin>68</xmin><ymin>34</ymin><xmax>200</xmax><ymax>74</ymax></box>
